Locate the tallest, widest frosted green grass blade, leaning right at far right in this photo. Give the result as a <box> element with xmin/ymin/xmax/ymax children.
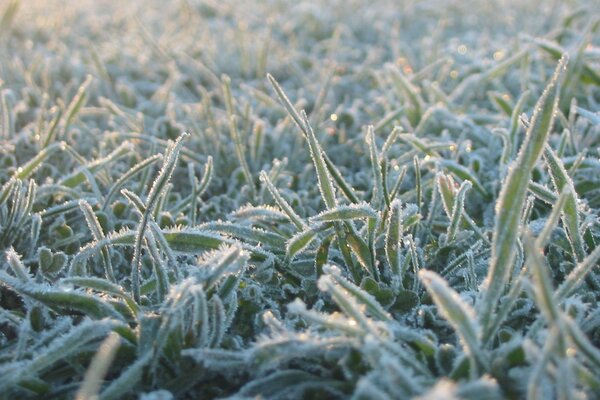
<box><xmin>480</xmin><ymin>56</ymin><xmax>567</xmax><ymax>327</ymax></box>
